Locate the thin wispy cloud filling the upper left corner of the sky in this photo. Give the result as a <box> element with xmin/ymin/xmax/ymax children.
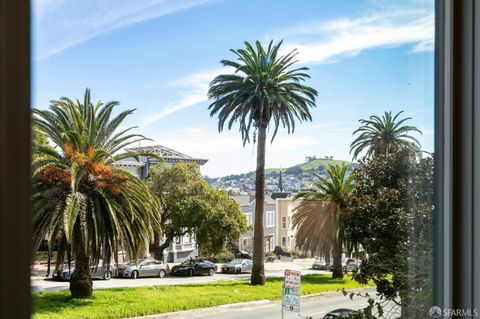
<box><xmin>33</xmin><ymin>0</ymin><xmax>212</xmax><ymax>59</ymax></box>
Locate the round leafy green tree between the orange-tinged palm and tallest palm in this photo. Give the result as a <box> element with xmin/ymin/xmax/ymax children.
<box><xmin>147</xmin><ymin>163</ymin><xmax>247</xmax><ymax>257</ymax></box>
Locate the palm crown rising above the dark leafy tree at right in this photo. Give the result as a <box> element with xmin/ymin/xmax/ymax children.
<box><xmin>350</xmin><ymin>111</ymin><xmax>422</xmax><ymax>159</ymax></box>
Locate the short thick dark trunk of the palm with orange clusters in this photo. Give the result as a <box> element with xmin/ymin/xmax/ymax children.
<box><xmin>70</xmin><ymin>234</ymin><xmax>92</xmax><ymax>298</ymax></box>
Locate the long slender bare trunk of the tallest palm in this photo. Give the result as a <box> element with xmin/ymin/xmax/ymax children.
<box><xmin>251</xmin><ymin>125</ymin><xmax>267</xmax><ymax>285</ymax></box>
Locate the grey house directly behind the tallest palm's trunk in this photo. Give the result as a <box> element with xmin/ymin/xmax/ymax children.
<box><xmin>230</xmin><ymin>195</ymin><xmax>277</xmax><ymax>252</ymax></box>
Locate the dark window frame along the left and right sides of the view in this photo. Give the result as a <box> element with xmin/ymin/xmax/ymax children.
<box><xmin>0</xmin><ymin>0</ymin><xmax>480</xmax><ymax>319</ymax></box>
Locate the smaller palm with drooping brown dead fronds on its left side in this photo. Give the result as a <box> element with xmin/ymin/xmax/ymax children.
<box><xmin>292</xmin><ymin>163</ymin><xmax>354</xmax><ymax>278</ymax></box>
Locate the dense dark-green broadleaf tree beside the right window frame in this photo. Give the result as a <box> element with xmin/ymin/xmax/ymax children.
<box><xmin>345</xmin><ymin>149</ymin><xmax>434</xmax><ymax>318</ymax></box>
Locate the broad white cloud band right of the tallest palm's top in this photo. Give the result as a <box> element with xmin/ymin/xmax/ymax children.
<box><xmin>279</xmin><ymin>11</ymin><xmax>434</xmax><ymax>64</ymax></box>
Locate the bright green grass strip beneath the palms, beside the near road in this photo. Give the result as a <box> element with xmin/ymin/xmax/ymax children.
<box><xmin>33</xmin><ymin>274</ymin><xmax>372</xmax><ymax>319</ymax></box>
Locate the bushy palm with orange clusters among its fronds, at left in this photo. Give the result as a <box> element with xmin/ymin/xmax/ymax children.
<box><xmin>32</xmin><ymin>89</ymin><xmax>160</xmax><ymax>298</ymax></box>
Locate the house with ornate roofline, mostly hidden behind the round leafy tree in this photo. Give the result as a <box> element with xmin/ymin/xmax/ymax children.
<box><xmin>115</xmin><ymin>145</ymin><xmax>208</xmax><ymax>262</ymax></box>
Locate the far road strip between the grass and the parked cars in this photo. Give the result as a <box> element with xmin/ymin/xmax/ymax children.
<box><xmin>31</xmin><ymin>262</ymin><xmax>330</xmax><ymax>292</ymax></box>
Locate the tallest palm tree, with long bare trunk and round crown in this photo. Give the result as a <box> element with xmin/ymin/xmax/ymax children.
<box><xmin>208</xmin><ymin>41</ymin><xmax>317</xmax><ymax>285</ymax></box>
